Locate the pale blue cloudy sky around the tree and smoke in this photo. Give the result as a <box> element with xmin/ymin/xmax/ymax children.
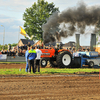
<box><xmin>0</xmin><ymin>0</ymin><xmax>100</xmax><ymax>45</ymax></box>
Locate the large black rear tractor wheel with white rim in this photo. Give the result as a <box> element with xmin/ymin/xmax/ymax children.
<box><xmin>57</xmin><ymin>51</ymin><xmax>72</xmax><ymax>68</ymax></box>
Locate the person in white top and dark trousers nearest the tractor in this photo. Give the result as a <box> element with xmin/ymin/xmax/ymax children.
<box><xmin>35</xmin><ymin>46</ymin><xmax>42</xmax><ymax>72</ymax></box>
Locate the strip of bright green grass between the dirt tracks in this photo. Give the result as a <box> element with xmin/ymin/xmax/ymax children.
<box><xmin>0</xmin><ymin>68</ymin><xmax>99</xmax><ymax>75</ymax></box>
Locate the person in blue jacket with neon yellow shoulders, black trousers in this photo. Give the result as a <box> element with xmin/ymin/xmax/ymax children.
<box><xmin>27</xmin><ymin>46</ymin><xmax>37</xmax><ymax>73</ymax></box>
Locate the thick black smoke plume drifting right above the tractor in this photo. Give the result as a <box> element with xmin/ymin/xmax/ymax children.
<box><xmin>42</xmin><ymin>2</ymin><xmax>100</xmax><ymax>44</ymax></box>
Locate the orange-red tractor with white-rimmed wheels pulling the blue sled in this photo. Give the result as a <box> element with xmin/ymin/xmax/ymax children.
<box><xmin>41</xmin><ymin>43</ymin><xmax>72</xmax><ymax>68</ymax></box>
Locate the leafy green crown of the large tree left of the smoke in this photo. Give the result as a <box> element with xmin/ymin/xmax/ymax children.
<box><xmin>23</xmin><ymin>0</ymin><xmax>59</xmax><ymax>40</ymax></box>
